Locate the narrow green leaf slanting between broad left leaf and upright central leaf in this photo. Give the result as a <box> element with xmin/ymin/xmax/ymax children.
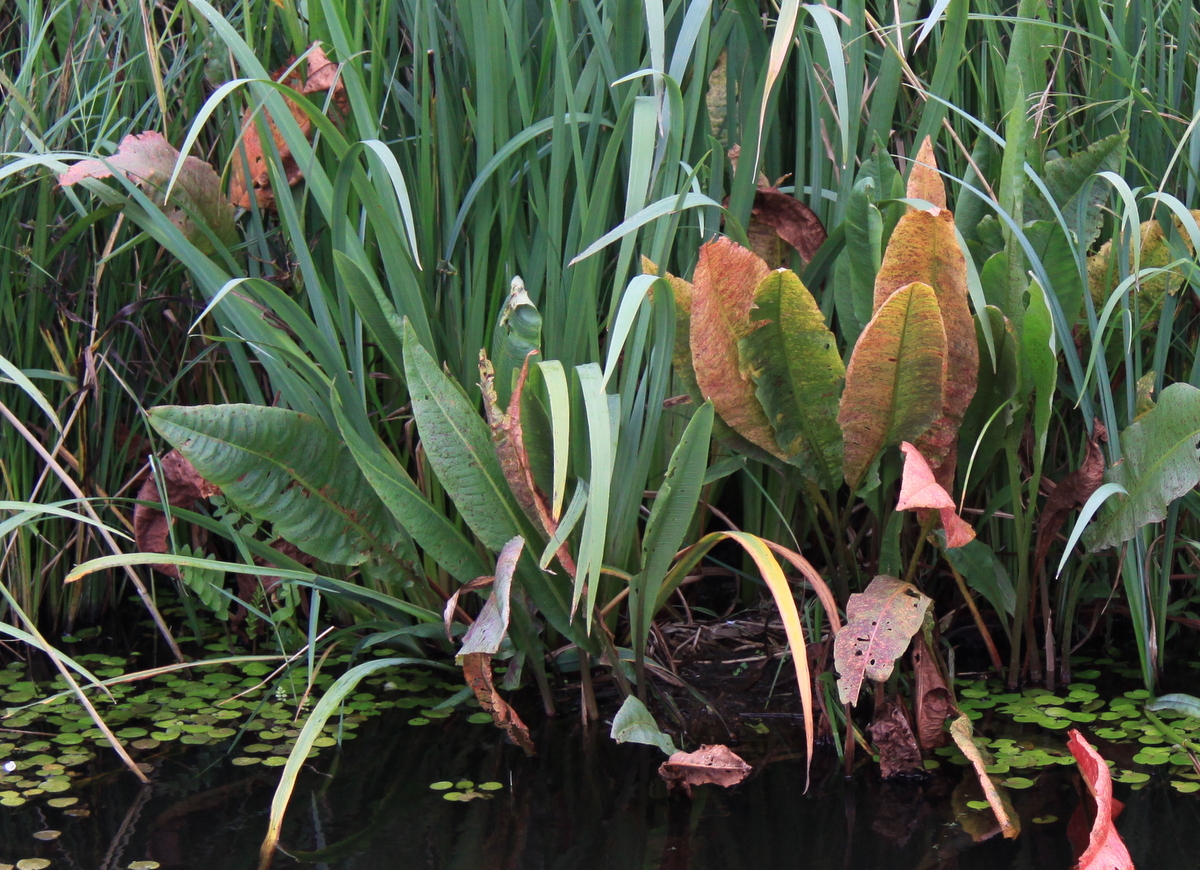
<box><xmin>332</xmin><ymin>395</ymin><xmax>488</xmax><ymax>583</ymax></box>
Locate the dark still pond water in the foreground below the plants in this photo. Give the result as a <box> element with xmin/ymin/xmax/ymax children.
<box><xmin>0</xmin><ymin>718</ymin><xmax>1200</xmax><ymax>870</ymax></box>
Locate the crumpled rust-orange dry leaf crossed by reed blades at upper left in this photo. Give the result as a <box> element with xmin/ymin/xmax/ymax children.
<box><xmin>229</xmin><ymin>42</ymin><xmax>349</xmax><ymax>209</ymax></box>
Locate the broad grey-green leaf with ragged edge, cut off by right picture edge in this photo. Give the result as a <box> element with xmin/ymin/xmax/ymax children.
<box><xmin>1084</xmin><ymin>384</ymin><xmax>1200</xmax><ymax>552</ymax></box>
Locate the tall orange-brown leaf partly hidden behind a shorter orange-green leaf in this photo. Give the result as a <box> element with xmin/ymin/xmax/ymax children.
<box><xmin>875</xmin><ymin>208</ymin><xmax>979</xmax><ymax>475</ymax></box>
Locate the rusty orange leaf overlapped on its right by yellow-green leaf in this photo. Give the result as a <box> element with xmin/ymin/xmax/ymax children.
<box><xmin>690</xmin><ymin>238</ymin><xmax>784</xmax><ymax>458</ymax></box>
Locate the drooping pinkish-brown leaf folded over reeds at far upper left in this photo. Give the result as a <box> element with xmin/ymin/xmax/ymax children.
<box><xmin>59</xmin><ymin>130</ymin><xmax>238</xmax><ymax>253</ymax></box>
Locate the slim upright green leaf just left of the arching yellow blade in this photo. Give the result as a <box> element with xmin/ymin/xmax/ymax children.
<box><xmin>629</xmin><ymin>402</ymin><xmax>713</xmax><ymax>661</ymax></box>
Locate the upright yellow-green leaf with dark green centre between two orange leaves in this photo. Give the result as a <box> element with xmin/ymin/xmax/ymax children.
<box><xmin>738</xmin><ymin>270</ymin><xmax>846</xmax><ymax>491</ymax></box>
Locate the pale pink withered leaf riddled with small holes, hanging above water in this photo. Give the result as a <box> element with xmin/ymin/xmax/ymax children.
<box><xmin>833</xmin><ymin>575</ymin><xmax>930</xmax><ymax>704</ymax></box>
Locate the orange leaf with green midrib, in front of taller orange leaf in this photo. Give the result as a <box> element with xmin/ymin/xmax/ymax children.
<box><xmin>838</xmin><ymin>283</ymin><xmax>946</xmax><ymax>488</ymax></box>
